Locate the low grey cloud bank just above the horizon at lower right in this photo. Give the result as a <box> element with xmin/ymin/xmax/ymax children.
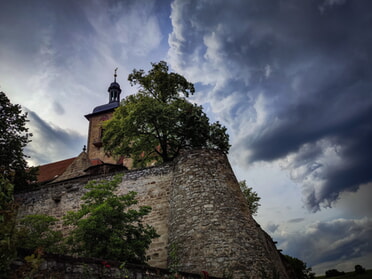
<box><xmin>275</xmin><ymin>218</ymin><xmax>372</xmax><ymax>266</ymax></box>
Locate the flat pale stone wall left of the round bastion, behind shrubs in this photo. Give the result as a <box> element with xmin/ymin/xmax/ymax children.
<box><xmin>16</xmin><ymin>165</ymin><xmax>172</xmax><ymax>268</ymax></box>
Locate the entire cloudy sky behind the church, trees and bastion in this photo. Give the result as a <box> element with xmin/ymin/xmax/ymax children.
<box><xmin>0</xmin><ymin>0</ymin><xmax>372</xmax><ymax>275</ymax></box>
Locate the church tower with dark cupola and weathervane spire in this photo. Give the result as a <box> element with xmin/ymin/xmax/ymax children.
<box><xmin>85</xmin><ymin>68</ymin><xmax>121</xmax><ymax>164</ymax></box>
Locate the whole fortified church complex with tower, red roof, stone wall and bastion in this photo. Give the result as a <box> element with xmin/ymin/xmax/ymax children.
<box><xmin>16</xmin><ymin>71</ymin><xmax>295</xmax><ymax>279</ymax></box>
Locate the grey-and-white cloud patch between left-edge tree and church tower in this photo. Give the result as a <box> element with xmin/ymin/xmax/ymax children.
<box><xmin>25</xmin><ymin>111</ymin><xmax>86</xmax><ymax>165</ymax></box>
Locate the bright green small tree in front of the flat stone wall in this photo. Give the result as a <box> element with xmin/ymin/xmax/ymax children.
<box><xmin>64</xmin><ymin>176</ymin><xmax>158</xmax><ymax>263</ymax></box>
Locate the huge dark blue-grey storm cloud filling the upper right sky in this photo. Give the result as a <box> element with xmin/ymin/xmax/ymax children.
<box><xmin>169</xmin><ymin>0</ymin><xmax>372</xmax><ymax>211</ymax></box>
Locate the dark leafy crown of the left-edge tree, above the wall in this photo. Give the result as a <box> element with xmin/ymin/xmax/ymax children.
<box><xmin>0</xmin><ymin>92</ymin><xmax>37</xmax><ymax>190</ymax></box>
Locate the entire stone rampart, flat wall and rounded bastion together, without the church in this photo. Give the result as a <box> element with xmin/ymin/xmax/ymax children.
<box><xmin>18</xmin><ymin>150</ymin><xmax>289</xmax><ymax>278</ymax></box>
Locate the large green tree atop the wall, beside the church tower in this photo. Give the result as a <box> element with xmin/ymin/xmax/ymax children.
<box><xmin>103</xmin><ymin>61</ymin><xmax>230</xmax><ymax>165</ymax></box>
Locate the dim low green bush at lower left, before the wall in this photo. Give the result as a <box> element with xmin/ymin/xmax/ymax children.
<box><xmin>17</xmin><ymin>214</ymin><xmax>63</xmax><ymax>253</ymax></box>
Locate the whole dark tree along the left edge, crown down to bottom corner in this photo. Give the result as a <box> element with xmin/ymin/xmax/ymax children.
<box><xmin>0</xmin><ymin>92</ymin><xmax>37</xmax><ymax>278</ymax></box>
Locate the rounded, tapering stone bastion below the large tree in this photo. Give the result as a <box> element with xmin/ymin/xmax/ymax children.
<box><xmin>169</xmin><ymin>151</ymin><xmax>287</xmax><ymax>278</ymax></box>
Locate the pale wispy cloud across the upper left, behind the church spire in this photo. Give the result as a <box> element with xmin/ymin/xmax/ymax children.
<box><xmin>0</xmin><ymin>0</ymin><xmax>169</xmax><ymax>135</ymax></box>
